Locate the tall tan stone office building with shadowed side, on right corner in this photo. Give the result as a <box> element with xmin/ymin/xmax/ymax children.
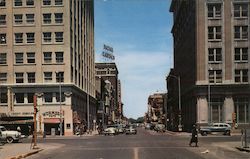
<box><xmin>167</xmin><ymin>0</ymin><xmax>250</xmax><ymax>130</ymax></box>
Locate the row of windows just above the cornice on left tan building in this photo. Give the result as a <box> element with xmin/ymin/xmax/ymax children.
<box><xmin>0</xmin><ymin>72</ymin><xmax>64</xmax><ymax>83</ymax></box>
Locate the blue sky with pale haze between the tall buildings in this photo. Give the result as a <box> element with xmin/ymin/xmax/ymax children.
<box><xmin>94</xmin><ymin>0</ymin><xmax>173</xmax><ymax>119</ymax></box>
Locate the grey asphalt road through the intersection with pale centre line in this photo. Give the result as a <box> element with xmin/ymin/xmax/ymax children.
<box><xmin>26</xmin><ymin>129</ymin><xmax>249</xmax><ymax>159</ymax></box>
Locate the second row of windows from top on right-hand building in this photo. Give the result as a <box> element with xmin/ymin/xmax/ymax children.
<box><xmin>208</xmin><ymin>26</ymin><xmax>248</xmax><ymax>40</ymax></box>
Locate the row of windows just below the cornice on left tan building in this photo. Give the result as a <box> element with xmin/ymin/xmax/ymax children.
<box><xmin>0</xmin><ymin>92</ymin><xmax>65</xmax><ymax>104</ymax></box>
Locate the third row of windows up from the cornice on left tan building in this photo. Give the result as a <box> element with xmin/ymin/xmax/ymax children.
<box><xmin>0</xmin><ymin>32</ymin><xmax>63</xmax><ymax>44</ymax></box>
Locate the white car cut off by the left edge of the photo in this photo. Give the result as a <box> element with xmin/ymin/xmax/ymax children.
<box><xmin>0</xmin><ymin>126</ymin><xmax>21</xmax><ymax>143</ymax></box>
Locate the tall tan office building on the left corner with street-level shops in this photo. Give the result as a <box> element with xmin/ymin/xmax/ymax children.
<box><xmin>0</xmin><ymin>0</ymin><xmax>95</xmax><ymax>135</ymax></box>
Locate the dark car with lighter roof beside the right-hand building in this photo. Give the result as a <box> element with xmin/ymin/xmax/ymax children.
<box><xmin>199</xmin><ymin>123</ymin><xmax>231</xmax><ymax>136</ymax></box>
